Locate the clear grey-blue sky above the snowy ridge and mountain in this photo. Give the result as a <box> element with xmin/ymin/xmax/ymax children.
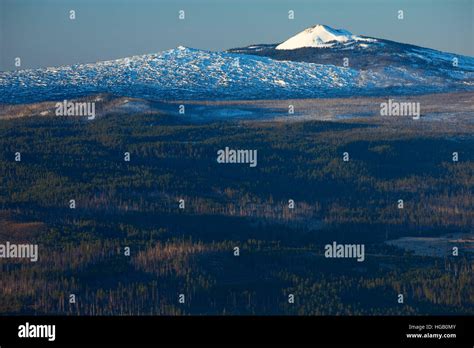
<box><xmin>0</xmin><ymin>0</ymin><xmax>474</xmax><ymax>70</ymax></box>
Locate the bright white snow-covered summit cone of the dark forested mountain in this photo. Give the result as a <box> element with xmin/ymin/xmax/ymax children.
<box><xmin>276</xmin><ymin>24</ymin><xmax>376</xmax><ymax>50</ymax></box>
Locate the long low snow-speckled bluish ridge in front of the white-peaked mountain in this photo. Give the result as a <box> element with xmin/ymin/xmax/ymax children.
<box><xmin>0</xmin><ymin>47</ymin><xmax>376</xmax><ymax>103</ymax></box>
